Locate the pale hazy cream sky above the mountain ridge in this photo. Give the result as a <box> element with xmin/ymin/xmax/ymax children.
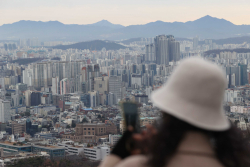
<box><xmin>0</xmin><ymin>0</ymin><xmax>250</xmax><ymax>26</ymax></box>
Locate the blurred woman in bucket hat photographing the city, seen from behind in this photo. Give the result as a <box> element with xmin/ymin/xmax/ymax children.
<box><xmin>100</xmin><ymin>58</ymin><xmax>250</xmax><ymax>167</ymax></box>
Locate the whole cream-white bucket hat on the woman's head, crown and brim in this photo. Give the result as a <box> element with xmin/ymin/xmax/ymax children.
<box><xmin>151</xmin><ymin>58</ymin><xmax>230</xmax><ymax>131</ymax></box>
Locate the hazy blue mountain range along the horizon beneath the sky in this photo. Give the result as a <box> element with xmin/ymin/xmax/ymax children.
<box><xmin>0</xmin><ymin>16</ymin><xmax>250</xmax><ymax>42</ymax></box>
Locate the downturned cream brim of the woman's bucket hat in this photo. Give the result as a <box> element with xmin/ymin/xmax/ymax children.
<box><xmin>151</xmin><ymin>87</ymin><xmax>231</xmax><ymax>131</ymax></box>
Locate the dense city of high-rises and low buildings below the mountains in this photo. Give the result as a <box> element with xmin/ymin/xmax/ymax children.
<box><xmin>0</xmin><ymin>32</ymin><xmax>250</xmax><ymax>166</ymax></box>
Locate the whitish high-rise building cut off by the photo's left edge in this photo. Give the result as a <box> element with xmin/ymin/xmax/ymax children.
<box><xmin>0</xmin><ymin>99</ymin><xmax>11</xmax><ymax>123</ymax></box>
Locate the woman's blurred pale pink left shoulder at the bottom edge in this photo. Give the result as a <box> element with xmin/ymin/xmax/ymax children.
<box><xmin>115</xmin><ymin>155</ymin><xmax>148</xmax><ymax>167</ymax></box>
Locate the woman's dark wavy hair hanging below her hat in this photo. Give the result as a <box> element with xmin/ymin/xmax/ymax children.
<box><xmin>147</xmin><ymin>113</ymin><xmax>250</xmax><ymax>167</ymax></box>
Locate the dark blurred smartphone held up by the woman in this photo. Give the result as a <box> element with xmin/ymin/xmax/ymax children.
<box><xmin>121</xmin><ymin>101</ymin><xmax>140</xmax><ymax>133</ymax></box>
